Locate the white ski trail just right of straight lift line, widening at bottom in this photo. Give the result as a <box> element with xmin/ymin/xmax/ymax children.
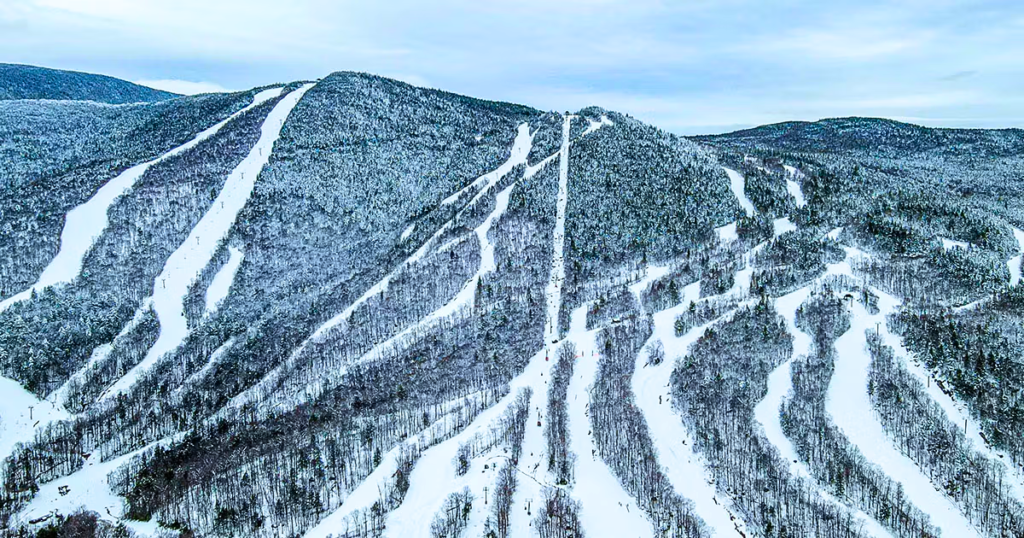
<box><xmin>565</xmin><ymin>304</ymin><xmax>653</xmax><ymax>538</ymax></box>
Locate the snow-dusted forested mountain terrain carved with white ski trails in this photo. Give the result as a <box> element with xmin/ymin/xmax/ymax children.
<box><xmin>0</xmin><ymin>67</ymin><xmax>1024</xmax><ymax>538</ymax></box>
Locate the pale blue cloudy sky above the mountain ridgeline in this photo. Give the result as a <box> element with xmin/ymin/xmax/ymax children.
<box><xmin>0</xmin><ymin>0</ymin><xmax>1024</xmax><ymax>134</ymax></box>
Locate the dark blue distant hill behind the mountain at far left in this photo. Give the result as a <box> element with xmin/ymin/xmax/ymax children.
<box><xmin>0</xmin><ymin>64</ymin><xmax>178</xmax><ymax>105</ymax></box>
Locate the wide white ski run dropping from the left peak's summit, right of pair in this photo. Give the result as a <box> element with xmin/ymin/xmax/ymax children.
<box><xmin>103</xmin><ymin>84</ymin><xmax>312</xmax><ymax>398</ymax></box>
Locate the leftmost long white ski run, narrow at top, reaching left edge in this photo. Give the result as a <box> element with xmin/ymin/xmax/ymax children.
<box><xmin>0</xmin><ymin>88</ymin><xmax>283</xmax><ymax>312</ymax></box>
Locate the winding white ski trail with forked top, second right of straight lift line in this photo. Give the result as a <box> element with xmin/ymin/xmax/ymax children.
<box><xmin>630</xmin><ymin>282</ymin><xmax>745</xmax><ymax>537</ymax></box>
